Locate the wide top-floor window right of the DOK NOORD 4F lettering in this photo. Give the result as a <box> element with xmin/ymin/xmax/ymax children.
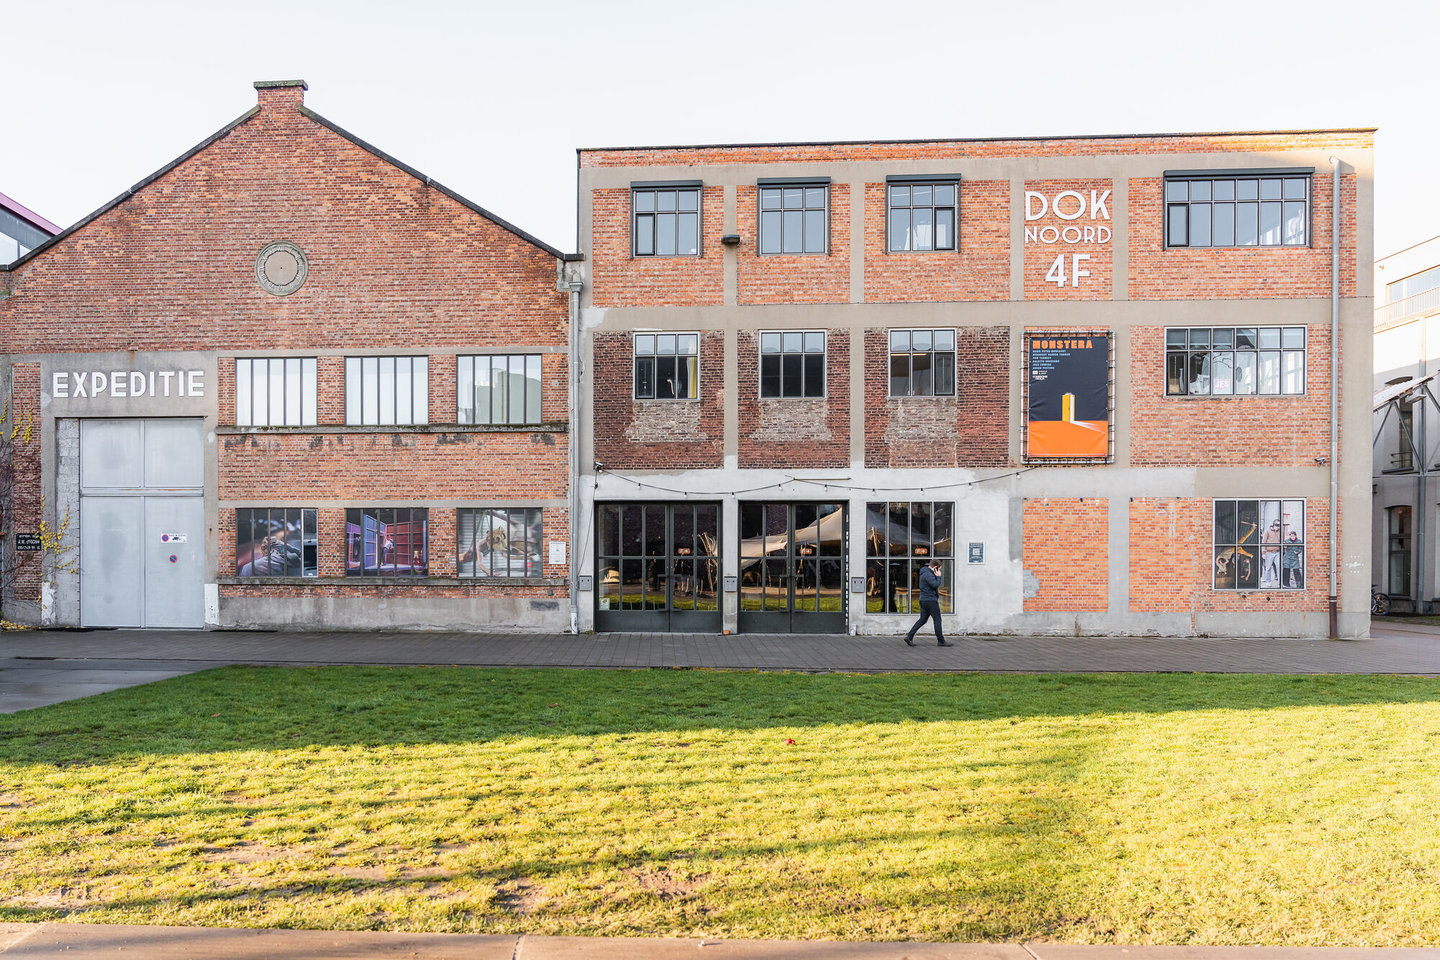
<box><xmin>1165</xmin><ymin>171</ymin><xmax>1310</xmax><ymax>246</ymax></box>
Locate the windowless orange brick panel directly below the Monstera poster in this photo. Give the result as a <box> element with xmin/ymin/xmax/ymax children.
<box><xmin>1022</xmin><ymin>497</ymin><xmax>1110</xmax><ymax>613</ymax></box>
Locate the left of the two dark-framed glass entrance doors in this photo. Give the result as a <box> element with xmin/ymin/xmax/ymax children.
<box><xmin>595</xmin><ymin>504</ymin><xmax>721</xmax><ymax>633</ymax></box>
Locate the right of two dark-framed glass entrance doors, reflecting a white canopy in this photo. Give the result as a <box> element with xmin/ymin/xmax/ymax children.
<box><xmin>739</xmin><ymin>502</ymin><xmax>848</xmax><ymax>633</ymax></box>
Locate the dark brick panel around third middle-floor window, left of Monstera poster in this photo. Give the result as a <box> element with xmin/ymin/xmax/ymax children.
<box><xmin>865</xmin><ymin>327</ymin><xmax>1009</xmax><ymax>468</ymax></box>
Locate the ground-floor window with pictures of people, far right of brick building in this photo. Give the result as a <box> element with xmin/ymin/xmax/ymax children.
<box><xmin>1214</xmin><ymin>499</ymin><xmax>1305</xmax><ymax>590</ymax></box>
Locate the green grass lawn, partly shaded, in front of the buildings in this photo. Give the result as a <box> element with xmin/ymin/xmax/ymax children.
<box><xmin>0</xmin><ymin>668</ymin><xmax>1440</xmax><ymax>946</ymax></box>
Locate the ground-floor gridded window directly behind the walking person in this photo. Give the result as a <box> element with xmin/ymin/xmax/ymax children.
<box><xmin>865</xmin><ymin>501</ymin><xmax>955</xmax><ymax>613</ymax></box>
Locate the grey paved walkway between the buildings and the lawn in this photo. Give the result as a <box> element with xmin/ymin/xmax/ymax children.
<box><xmin>0</xmin><ymin>620</ymin><xmax>1440</xmax><ymax>712</ymax></box>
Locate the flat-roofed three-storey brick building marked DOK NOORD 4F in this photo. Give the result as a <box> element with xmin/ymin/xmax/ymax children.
<box><xmin>576</xmin><ymin>130</ymin><xmax>1372</xmax><ymax>636</ymax></box>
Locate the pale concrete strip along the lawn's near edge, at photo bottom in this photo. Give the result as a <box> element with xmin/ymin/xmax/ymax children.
<box><xmin>0</xmin><ymin>923</ymin><xmax>1422</xmax><ymax>960</ymax></box>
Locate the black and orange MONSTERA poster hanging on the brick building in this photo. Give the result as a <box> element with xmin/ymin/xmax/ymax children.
<box><xmin>1025</xmin><ymin>332</ymin><xmax>1110</xmax><ymax>461</ymax></box>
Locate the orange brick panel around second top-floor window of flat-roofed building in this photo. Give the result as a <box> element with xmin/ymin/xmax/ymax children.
<box><xmin>736</xmin><ymin>183</ymin><xmax>850</xmax><ymax>304</ymax></box>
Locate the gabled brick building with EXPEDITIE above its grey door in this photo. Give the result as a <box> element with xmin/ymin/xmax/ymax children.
<box><xmin>0</xmin><ymin>81</ymin><xmax>575</xmax><ymax>629</ymax></box>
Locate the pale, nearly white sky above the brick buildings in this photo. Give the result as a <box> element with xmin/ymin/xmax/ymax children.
<box><xmin>0</xmin><ymin>0</ymin><xmax>1440</xmax><ymax>263</ymax></box>
